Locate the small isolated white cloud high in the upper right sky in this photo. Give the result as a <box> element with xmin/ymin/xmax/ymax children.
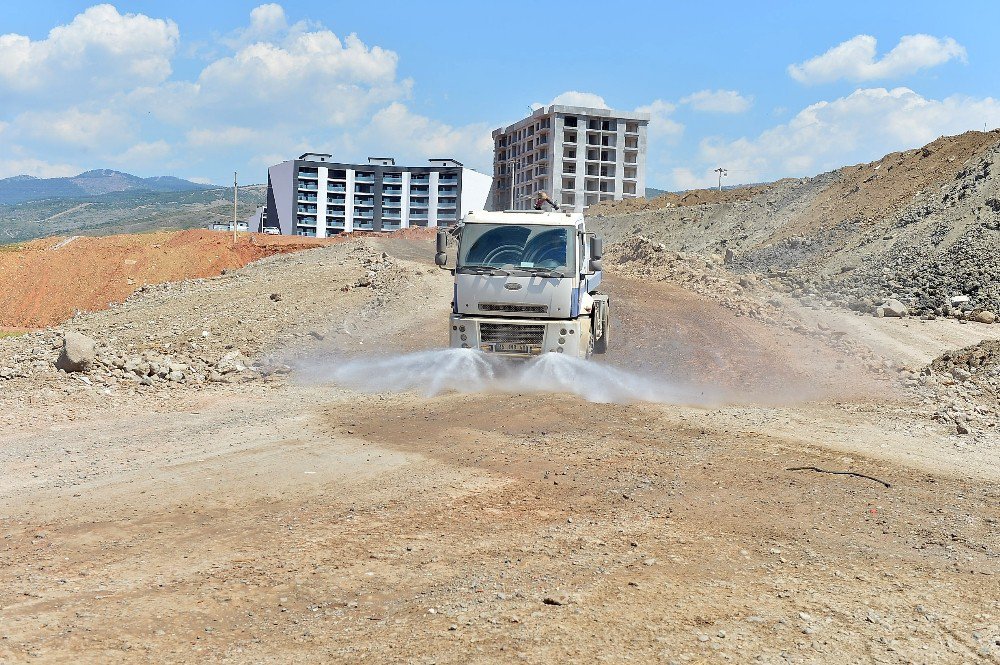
<box><xmin>788</xmin><ymin>35</ymin><xmax>966</xmax><ymax>84</ymax></box>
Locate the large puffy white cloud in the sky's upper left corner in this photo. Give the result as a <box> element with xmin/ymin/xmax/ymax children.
<box><xmin>0</xmin><ymin>5</ymin><xmax>180</xmax><ymax>102</ymax></box>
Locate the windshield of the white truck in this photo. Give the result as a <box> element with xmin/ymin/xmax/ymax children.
<box><xmin>458</xmin><ymin>224</ymin><xmax>575</xmax><ymax>275</ymax></box>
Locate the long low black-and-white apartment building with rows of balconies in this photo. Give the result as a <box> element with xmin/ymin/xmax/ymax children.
<box><xmin>251</xmin><ymin>153</ymin><xmax>492</xmax><ymax>238</ymax></box>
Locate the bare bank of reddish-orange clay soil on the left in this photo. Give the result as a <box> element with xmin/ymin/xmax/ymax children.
<box><xmin>0</xmin><ymin>229</ymin><xmax>347</xmax><ymax>329</ymax></box>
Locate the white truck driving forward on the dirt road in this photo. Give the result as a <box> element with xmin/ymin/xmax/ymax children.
<box><xmin>435</xmin><ymin>211</ymin><xmax>610</xmax><ymax>358</ymax></box>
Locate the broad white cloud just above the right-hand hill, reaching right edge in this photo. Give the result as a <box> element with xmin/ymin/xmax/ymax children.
<box><xmin>675</xmin><ymin>88</ymin><xmax>1000</xmax><ymax>184</ymax></box>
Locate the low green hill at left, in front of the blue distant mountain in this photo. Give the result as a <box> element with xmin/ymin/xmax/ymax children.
<box><xmin>0</xmin><ymin>180</ymin><xmax>266</xmax><ymax>243</ymax></box>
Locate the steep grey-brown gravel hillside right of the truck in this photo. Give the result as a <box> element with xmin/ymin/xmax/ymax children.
<box><xmin>591</xmin><ymin>130</ymin><xmax>1000</xmax><ymax>318</ymax></box>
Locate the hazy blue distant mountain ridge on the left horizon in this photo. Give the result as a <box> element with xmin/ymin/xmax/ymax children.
<box><xmin>0</xmin><ymin>169</ymin><xmax>214</xmax><ymax>204</ymax></box>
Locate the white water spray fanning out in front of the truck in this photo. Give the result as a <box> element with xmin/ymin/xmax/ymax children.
<box><xmin>298</xmin><ymin>349</ymin><xmax>711</xmax><ymax>404</ymax></box>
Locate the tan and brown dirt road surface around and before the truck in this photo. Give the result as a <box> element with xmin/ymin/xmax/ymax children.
<box><xmin>0</xmin><ymin>236</ymin><xmax>1000</xmax><ymax>663</ymax></box>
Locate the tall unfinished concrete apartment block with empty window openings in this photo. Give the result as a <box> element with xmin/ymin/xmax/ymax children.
<box><xmin>490</xmin><ymin>105</ymin><xmax>649</xmax><ymax>212</ymax></box>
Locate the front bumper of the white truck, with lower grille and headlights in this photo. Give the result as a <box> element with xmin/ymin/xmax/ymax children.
<box><xmin>449</xmin><ymin>314</ymin><xmax>590</xmax><ymax>358</ymax></box>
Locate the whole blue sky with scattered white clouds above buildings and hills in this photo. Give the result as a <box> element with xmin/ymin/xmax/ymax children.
<box><xmin>0</xmin><ymin>0</ymin><xmax>1000</xmax><ymax>189</ymax></box>
